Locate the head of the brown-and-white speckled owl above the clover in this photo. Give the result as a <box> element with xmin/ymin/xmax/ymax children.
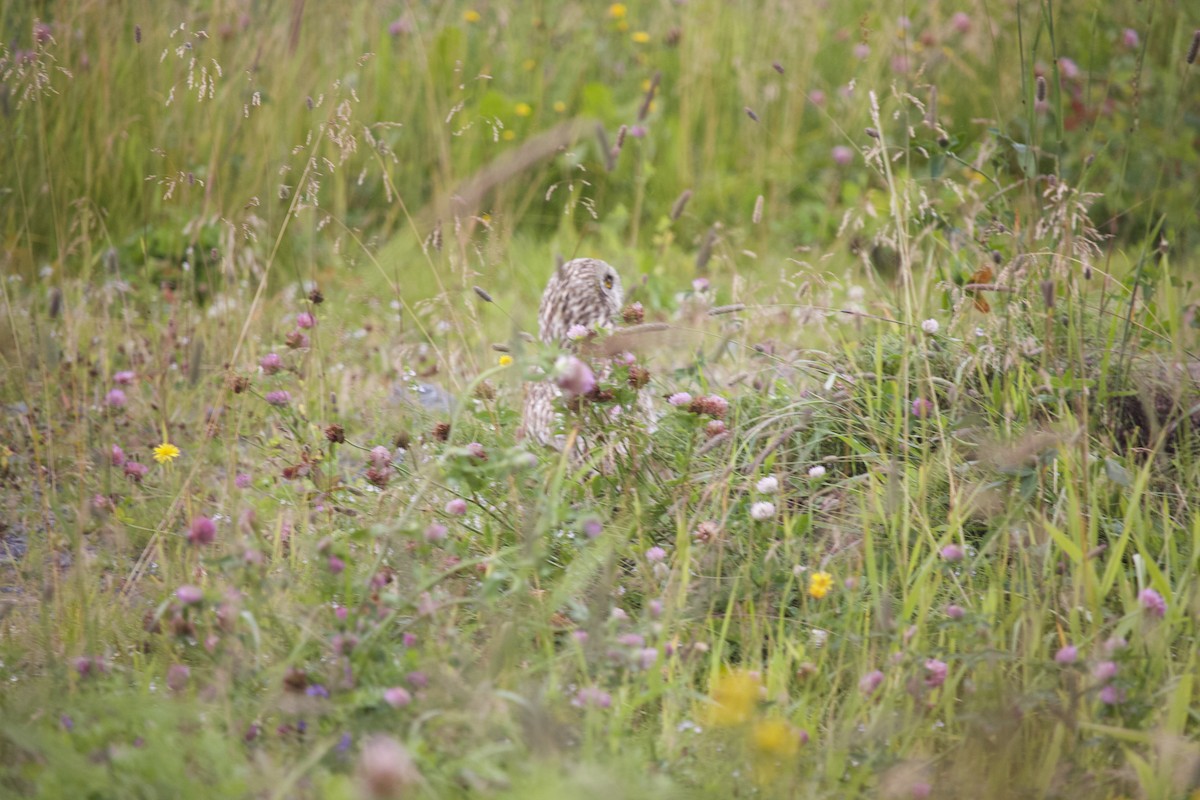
<box><xmin>538</xmin><ymin>258</ymin><xmax>625</xmax><ymax>345</ymax></box>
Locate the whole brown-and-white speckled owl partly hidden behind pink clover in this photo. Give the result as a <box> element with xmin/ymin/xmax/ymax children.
<box><xmin>518</xmin><ymin>258</ymin><xmax>625</xmax><ymax>446</ymax></box>
